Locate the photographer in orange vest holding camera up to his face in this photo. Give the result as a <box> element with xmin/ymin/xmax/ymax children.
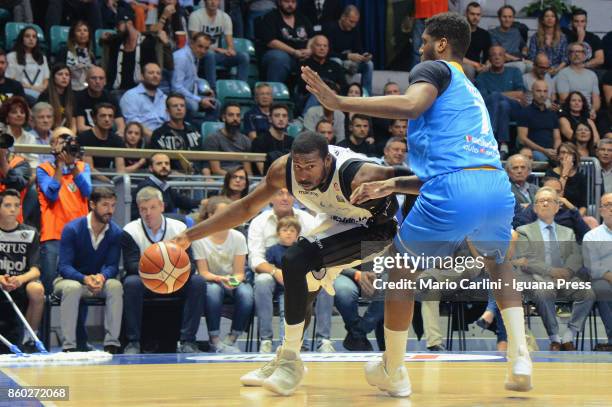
<box><xmin>36</xmin><ymin>127</ymin><xmax>91</xmax><ymax>292</ymax></box>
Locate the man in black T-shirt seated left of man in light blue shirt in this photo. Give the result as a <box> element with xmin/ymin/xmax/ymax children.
<box><xmin>74</xmin><ymin>65</ymin><xmax>125</xmax><ymax>137</ymax></box>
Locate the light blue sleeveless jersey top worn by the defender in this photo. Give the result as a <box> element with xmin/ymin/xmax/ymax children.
<box><xmin>408</xmin><ymin>61</ymin><xmax>502</xmax><ymax>181</ymax></box>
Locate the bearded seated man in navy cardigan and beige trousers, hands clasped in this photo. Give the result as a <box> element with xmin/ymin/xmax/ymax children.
<box><xmin>53</xmin><ymin>188</ymin><xmax>123</xmax><ymax>354</ymax></box>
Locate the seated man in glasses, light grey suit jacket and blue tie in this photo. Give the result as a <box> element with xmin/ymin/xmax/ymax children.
<box><xmin>516</xmin><ymin>187</ymin><xmax>595</xmax><ymax>351</ymax></box>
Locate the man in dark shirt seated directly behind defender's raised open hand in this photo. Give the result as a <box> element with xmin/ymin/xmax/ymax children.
<box><xmin>298</xmin><ymin>34</ymin><xmax>348</xmax><ymax>111</ymax></box>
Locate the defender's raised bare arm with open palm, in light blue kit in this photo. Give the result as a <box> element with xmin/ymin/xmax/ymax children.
<box><xmin>302</xmin><ymin>66</ymin><xmax>438</xmax><ymax>120</ymax></box>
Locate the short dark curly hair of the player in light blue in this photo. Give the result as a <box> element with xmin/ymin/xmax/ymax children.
<box><xmin>425</xmin><ymin>13</ymin><xmax>472</xmax><ymax>58</ymax></box>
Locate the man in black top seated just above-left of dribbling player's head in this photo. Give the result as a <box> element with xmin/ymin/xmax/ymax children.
<box><xmin>251</xmin><ymin>104</ymin><xmax>293</xmax><ymax>175</ymax></box>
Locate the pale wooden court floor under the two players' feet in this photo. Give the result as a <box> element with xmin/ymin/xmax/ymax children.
<box><xmin>0</xmin><ymin>352</ymin><xmax>612</xmax><ymax>407</ymax></box>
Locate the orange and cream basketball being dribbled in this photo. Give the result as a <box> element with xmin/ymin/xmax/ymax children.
<box><xmin>138</xmin><ymin>242</ymin><xmax>191</xmax><ymax>294</ymax></box>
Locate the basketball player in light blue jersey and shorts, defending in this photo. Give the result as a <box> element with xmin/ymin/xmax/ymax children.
<box><xmin>302</xmin><ymin>13</ymin><xmax>532</xmax><ymax>396</ymax></box>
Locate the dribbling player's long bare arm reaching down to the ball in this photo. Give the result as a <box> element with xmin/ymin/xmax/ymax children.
<box><xmin>172</xmin><ymin>156</ymin><xmax>287</xmax><ymax>249</ymax></box>
